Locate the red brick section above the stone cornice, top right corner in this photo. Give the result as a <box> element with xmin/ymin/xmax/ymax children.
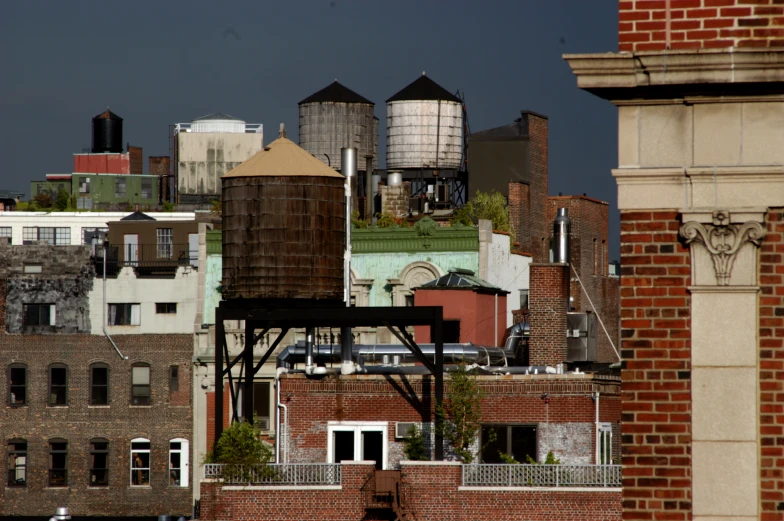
<box><xmin>618</xmin><ymin>0</ymin><xmax>784</xmax><ymax>51</ymax></box>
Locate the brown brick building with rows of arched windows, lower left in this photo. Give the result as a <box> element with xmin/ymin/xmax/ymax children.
<box><xmin>0</xmin><ymin>238</ymin><xmax>193</xmax><ymax>518</ymax></box>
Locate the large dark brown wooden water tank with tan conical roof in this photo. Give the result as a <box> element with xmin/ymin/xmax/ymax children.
<box><xmin>222</xmin><ymin>137</ymin><xmax>346</xmax><ymax>302</ymax></box>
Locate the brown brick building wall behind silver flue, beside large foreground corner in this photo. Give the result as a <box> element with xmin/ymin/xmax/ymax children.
<box><xmin>547</xmin><ymin>195</ymin><xmax>620</xmax><ymax>363</ymax></box>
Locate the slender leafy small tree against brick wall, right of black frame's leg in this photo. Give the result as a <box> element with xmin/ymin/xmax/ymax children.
<box><xmin>436</xmin><ymin>364</ymin><xmax>494</xmax><ymax>463</ymax></box>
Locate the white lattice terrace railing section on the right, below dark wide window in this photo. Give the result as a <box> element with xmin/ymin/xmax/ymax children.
<box><xmin>463</xmin><ymin>464</ymin><xmax>621</xmax><ymax>487</ymax></box>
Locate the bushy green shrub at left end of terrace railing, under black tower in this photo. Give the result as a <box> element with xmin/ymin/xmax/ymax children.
<box><xmin>204</xmin><ymin>418</ymin><xmax>275</xmax><ymax>482</ymax></box>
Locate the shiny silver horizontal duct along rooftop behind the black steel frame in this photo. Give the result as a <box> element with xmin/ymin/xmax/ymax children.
<box><xmin>277</xmin><ymin>342</ymin><xmax>514</xmax><ymax>372</ymax></box>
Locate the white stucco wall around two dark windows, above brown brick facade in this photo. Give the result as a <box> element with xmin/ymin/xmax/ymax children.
<box><xmin>89</xmin><ymin>266</ymin><xmax>198</xmax><ymax>335</ymax></box>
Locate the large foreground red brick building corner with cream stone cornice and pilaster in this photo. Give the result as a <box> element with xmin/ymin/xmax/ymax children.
<box><xmin>565</xmin><ymin>0</ymin><xmax>784</xmax><ymax>521</ymax></box>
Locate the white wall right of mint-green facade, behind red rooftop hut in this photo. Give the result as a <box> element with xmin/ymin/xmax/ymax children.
<box><xmin>486</xmin><ymin>233</ymin><xmax>531</xmax><ymax>327</ymax></box>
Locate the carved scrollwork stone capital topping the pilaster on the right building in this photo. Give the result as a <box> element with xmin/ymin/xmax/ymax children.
<box><xmin>680</xmin><ymin>210</ymin><xmax>765</xmax><ymax>286</ymax></box>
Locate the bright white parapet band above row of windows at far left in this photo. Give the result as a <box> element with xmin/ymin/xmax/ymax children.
<box><xmin>0</xmin><ymin>212</ymin><xmax>196</xmax><ymax>246</ymax></box>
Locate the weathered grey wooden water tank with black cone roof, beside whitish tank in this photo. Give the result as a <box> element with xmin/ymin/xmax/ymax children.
<box><xmin>299</xmin><ymin>80</ymin><xmax>378</xmax><ymax>171</ymax></box>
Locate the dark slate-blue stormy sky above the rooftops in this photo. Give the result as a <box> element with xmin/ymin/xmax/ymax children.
<box><xmin>0</xmin><ymin>0</ymin><xmax>618</xmax><ymax>258</ymax></box>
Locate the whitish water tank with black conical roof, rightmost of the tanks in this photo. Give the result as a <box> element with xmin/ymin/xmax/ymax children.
<box><xmin>387</xmin><ymin>73</ymin><xmax>463</xmax><ymax>170</ymax></box>
